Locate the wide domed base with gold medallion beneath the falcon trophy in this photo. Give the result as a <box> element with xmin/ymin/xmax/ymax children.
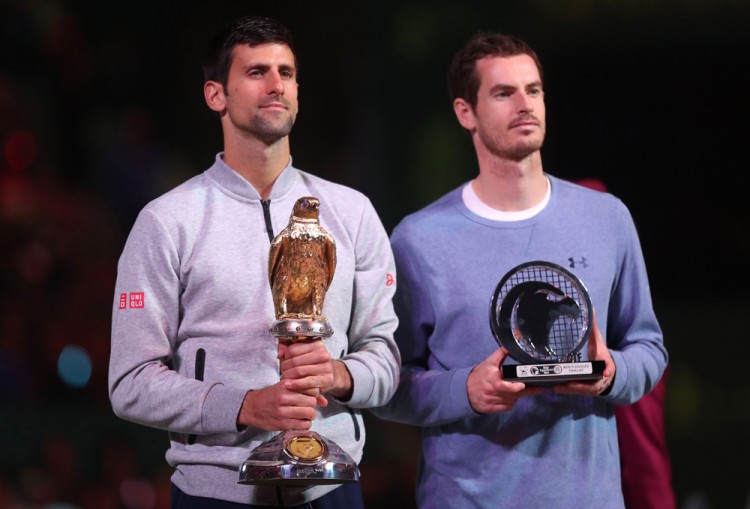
<box><xmin>238</xmin><ymin>430</ymin><xmax>359</xmax><ymax>486</ymax></box>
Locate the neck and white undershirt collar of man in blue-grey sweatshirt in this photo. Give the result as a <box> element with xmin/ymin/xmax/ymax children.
<box><xmin>472</xmin><ymin>151</ymin><xmax>547</xmax><ymax>212</ymax></box>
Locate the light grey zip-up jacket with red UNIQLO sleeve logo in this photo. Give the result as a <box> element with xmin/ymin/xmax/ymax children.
<box><xmin>109</xmin><ymin>153</ymin><xmax>400</xmax><ymax>505</ymax></box>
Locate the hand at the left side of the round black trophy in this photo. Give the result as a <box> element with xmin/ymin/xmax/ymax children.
<box><xmin>466</xmin><ymin>347</ymin><xmax>543</xmax><ymax>414</ymax></box>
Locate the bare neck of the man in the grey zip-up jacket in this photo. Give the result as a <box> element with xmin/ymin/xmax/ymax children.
<box><xmin>224</xmin><ymin>136</ymin><xmax>290</xmax><ymax>200</ymax></box>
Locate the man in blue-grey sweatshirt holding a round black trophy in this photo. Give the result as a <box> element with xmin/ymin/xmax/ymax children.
<box><xmin>375</xmin><ymin>34</ymin><xmax>667</xmax><ymax>509</ymax></box>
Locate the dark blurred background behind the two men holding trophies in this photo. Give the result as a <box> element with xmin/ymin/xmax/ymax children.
<box><xmin>0</xmin><ymin>0</ymin><xmax>750</xmax><ymax>509</ymax></box>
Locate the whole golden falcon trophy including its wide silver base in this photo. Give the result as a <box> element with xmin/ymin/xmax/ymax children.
<box><xmin>239</xmin><ymin>196</ymin><xmax>359</xmax><ymax>485</ymax></box>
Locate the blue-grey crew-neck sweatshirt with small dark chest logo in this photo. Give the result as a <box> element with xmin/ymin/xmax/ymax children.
<box><xmin>375</xmin><ymin>176</ymin><xmax>667</xmax><ymax>509</ymax></box>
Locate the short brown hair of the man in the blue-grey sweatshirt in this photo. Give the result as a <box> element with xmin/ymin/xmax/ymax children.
<box><xmin>448</xmin><ymin>34</ymin><xmax>542</xmax><ymax>108</ymax></box>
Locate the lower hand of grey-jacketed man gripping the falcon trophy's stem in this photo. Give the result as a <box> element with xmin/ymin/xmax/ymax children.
<box><xmin>237</xmin><ymin>381</ymin><xmax>319</xmax><ymax>431</ymax></box>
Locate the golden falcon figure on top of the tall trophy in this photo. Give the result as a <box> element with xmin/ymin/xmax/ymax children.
<box><xmin>268</xmin><ymin>196</ymin><xmax>336</xmax><ymax>320</ymax></box>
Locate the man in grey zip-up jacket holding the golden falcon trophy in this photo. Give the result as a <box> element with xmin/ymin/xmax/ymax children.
<box><xmin>109</xmin><ymin>17</ymin><xmax>399</xmax><ymax>508</ymax></box>
